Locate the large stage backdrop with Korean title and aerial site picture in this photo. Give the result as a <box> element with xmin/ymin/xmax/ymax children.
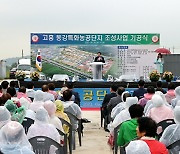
<box><xmin>31</xmin><ymin>33</ymin><xmax>160</xmax><ymax>78</ymax></box>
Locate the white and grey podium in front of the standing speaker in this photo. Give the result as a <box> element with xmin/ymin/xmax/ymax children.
<box><xmin>90</xmin><ymin>62</ymin><xmax>105</xmax><ymax>81</ymax></box>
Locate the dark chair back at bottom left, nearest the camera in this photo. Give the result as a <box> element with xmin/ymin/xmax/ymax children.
<box><xmin>29</xmin><ymin>136</ymin><xmax>65</xmax><ymax>154</ymax></box>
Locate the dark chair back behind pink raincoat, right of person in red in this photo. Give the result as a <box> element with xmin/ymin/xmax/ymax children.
<box><xmin>157</xmin><ymin>119</ymin><xmax>175</xmax><ymax>138</ymax></box>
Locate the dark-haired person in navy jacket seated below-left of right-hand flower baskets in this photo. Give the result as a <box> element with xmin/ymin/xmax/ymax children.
<box><xmin>133</xmin><ymin>80</ymin><xmax>147</xmax><ymax>99</ymax></box>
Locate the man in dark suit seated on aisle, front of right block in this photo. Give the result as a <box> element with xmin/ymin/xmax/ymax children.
<box><xmin>101</xmin><ymin>85</ymin><xmax>117</xmax><ymax>130</ymax></box>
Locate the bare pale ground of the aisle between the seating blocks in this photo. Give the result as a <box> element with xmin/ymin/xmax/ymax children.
<box><xmin>73</xmin><ymin>111</ymin><xmax>113</xmax><ymax>154</ymax></box>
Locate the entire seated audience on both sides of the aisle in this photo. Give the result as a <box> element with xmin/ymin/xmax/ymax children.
<box><xmin>0</xmin><ymin>80</ymin><xmax>180</xmax><ymax>154</ymax></box>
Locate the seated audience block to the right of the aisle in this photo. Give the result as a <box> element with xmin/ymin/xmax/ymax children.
<box><xmin>101</xmin><ymin>80</ymin><xmax>180</xmax><ymax>154</ymax></box>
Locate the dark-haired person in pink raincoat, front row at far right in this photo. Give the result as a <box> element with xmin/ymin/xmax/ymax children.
<box><xmin>165</xmin><ymin>82</ymin><xmax>176</xmax><ymax>105</ymax></box>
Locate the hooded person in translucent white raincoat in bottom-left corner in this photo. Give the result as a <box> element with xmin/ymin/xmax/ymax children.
<box><xmin>0</xmin><ymin>121</ymin><xmax>34</xmax><ymax>154</ymax></box>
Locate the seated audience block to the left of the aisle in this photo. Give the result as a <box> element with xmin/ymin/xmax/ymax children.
<box><xmin>0</xmin><ymin>81</ymin><xmax>82</xmax><ymax>154</ymax></box>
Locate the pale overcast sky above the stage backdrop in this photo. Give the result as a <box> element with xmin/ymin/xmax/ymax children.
<box><xmin>0</xmin><ymin>0</ymin><xmax>180</xmax><ymax>59</ymax></box>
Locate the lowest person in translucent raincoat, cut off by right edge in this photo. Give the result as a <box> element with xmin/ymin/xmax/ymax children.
<box><xmin>160</xmin><ymin>106</ymin><xmax>180</xmax><ymax>154</ymax></box>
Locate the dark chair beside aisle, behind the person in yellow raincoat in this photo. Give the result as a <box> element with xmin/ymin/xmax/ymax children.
<box><xmin>59</xmin><ymin>117</ymin><xmax>72</xmax><ymax>154</ymax></box>
